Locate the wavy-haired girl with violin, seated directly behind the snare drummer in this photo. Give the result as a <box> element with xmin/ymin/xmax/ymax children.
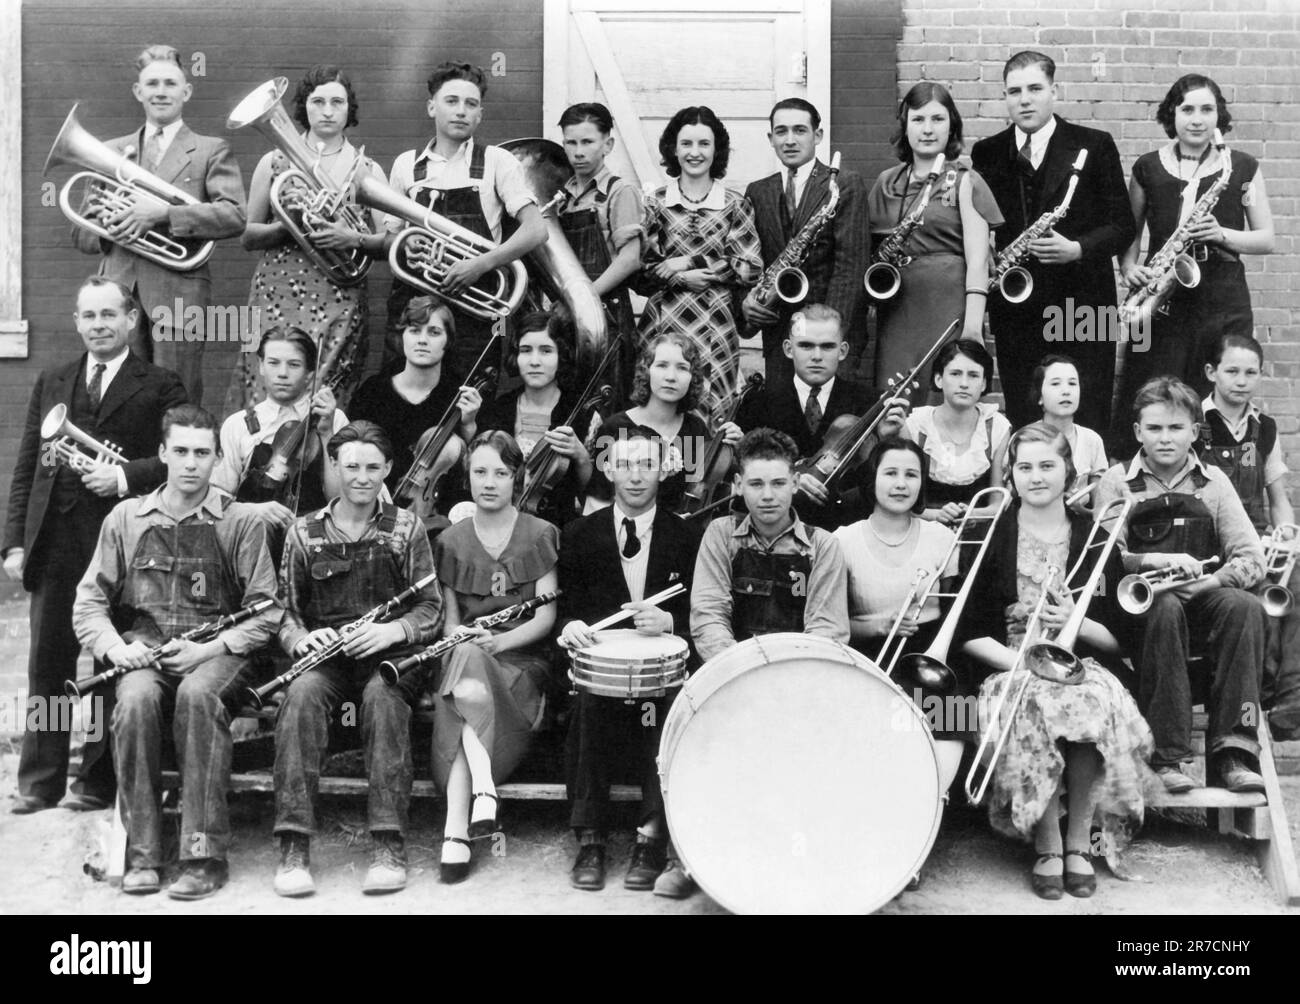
<box><xmin>586</xmin><ymin>332</ymin><xmax>742</xmax><ymax>512</ymax></box>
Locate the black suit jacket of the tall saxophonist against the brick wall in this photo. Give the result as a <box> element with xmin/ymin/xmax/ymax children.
<box><xmin>971</xmin><ymin>116</ymin><xmax>1138</xmax><ymax>309</ymax></box>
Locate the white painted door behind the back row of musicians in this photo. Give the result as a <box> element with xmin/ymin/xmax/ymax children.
<box><xmin>542</xmin><ymin>0</ymin><xmax>831</xmax><ymax>190</ymax></box>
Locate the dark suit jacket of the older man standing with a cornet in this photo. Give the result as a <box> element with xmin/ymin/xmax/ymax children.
<box><xmin>0</xmin><ymin>352</ymin><xmax>186</xmax><ymax>592</ymax></box>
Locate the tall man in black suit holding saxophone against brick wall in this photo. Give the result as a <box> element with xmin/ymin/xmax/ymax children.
<box><xmin>971</xmin><ymin>52</ymin><xmax>1135</xmax><ymax>434</ymax></box>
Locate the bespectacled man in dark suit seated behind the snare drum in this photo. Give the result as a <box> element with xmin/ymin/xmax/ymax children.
<box><xmin>559</xmin><ymin>427</ymin><xmax>698</xmax><ymax>892</ymax></box>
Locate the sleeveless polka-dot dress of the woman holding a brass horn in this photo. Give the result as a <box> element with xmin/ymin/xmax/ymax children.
<box><xmin>225</xmin><ymin>142</ymin><xmax>385</xmax><ymax>415</ymax></box>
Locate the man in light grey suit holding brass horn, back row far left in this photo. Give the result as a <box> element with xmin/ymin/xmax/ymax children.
<box><xmin>73</xmin><ymin>46</ymin><xmax>247</xmax><ymax>403</ymax></box>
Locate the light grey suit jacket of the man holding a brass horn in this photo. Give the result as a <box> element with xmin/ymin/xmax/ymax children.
<box><xmin>73</xmin><ymin>125</ymin><xmax>247</xmax><ymax>320</ymax></box>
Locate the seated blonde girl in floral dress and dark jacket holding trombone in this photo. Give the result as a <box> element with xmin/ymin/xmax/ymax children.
<box><xmin>958</xmin><ymin>423</ymin><xmax>1156</xmax><ymax>900</ymax></box>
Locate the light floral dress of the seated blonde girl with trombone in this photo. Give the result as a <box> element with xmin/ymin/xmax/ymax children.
<box><xmin>980</xmin><ymin>527</ymin><xmax>1154</xmax><ymax>869</ymax></box>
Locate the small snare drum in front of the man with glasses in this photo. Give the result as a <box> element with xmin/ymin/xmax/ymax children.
<box><xmin>569</xmin><ymin>631</ymin><xmax>688</xmax><ymax>701</ymax></box>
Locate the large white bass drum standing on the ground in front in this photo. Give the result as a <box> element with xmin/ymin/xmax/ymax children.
<box><xmin>659</xmin><ymin>633</ymin><xmax>943</xmax><ymax>913</ymax></box>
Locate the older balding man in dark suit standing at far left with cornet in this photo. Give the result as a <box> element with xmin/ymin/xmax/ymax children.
<box><xmin>0</xmin><ymin>276</ymin><xmax>186</xmax><ymax>813</ymax></box>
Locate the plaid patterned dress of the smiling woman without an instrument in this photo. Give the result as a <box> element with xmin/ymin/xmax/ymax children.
<box><xmin>641</xmin><ymin>181</ymin><xmax>763</xmax><ymax>429</ymax></box>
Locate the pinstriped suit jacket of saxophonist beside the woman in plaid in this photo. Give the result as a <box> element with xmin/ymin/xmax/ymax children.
<box><xmin>745</xmin><ymin>160</ymin><xmax>871</xmax><ymax>351</ymax></box>
